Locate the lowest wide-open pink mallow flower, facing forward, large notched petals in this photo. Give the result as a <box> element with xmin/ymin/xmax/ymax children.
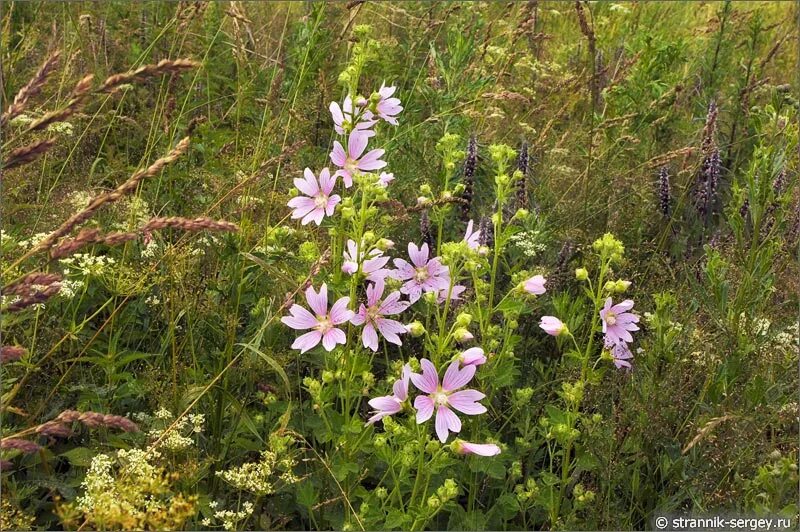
<box><xmin>411</xmin><ymin>358</ymin><xmax>486</xmax><ymax>443</ymax></box>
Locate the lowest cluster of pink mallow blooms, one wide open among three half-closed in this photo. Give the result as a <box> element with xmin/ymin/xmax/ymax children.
<box><xmin>367</xmin><ymin>356</ymin><xmax>500</xmax><ymax>456</ymax></box>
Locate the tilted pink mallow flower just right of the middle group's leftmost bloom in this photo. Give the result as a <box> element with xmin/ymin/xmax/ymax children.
<box><xmin>350</xmin><ymin>279</ymin><xmax>411</xmax><ymax>351</ymax></box>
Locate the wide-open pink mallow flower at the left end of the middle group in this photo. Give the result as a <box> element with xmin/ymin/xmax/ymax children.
<box><xmin>281</xmin><ymin>283</ymin><xmax>353</xmax><ymax>353</ymax></box>
